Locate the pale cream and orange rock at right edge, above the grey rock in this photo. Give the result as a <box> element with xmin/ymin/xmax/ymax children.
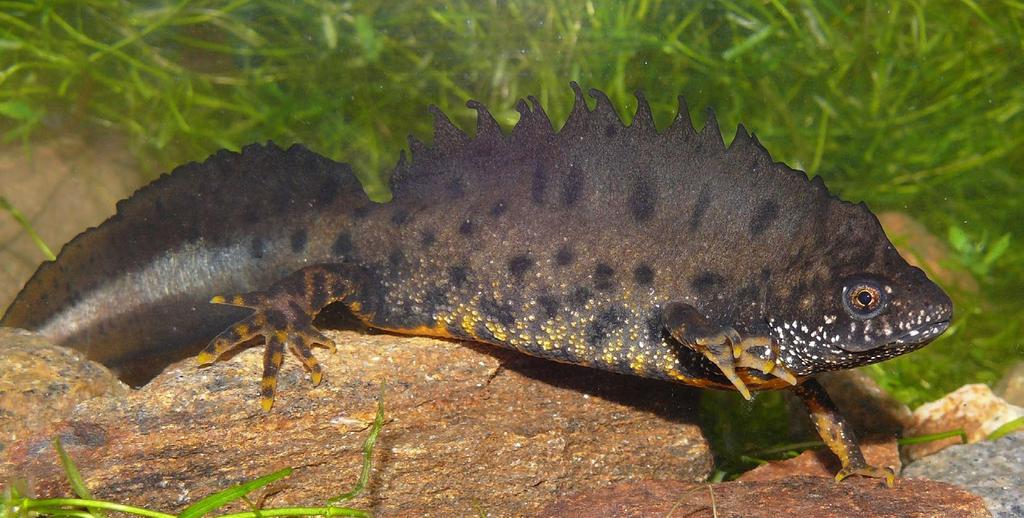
<box><xmin>903</xmin><ymin>384</ymin><xmax>1024</xmax><ymax>461</ymax></box>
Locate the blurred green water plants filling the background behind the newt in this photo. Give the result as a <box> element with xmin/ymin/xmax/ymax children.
<box><xmin>0</xmin><ymin>0</ymin><xmax>1024</xmax><ymax>477</ymax></box>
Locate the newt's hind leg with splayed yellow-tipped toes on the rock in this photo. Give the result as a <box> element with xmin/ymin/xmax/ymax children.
<box><xmin>197</xmin><ymin>264</ymin><xmax>354</xmax><ymax>412</ymax></box>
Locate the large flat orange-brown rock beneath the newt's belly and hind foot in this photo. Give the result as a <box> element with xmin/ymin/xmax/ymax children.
<box><xmin>0</xmin><ymin>332</ymin><xmax>712</xmax><ymax>516</ymax></box>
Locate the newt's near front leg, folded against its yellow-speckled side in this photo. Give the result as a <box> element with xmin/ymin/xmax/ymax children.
<box><xmin>663</xmin><ymin>302</ymin><xmax>797</xmax><ymax>399</ymax></box>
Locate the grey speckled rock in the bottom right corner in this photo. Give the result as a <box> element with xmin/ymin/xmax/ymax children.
<box><xmin>903</xmin><ymin>431</ymin><xmax>1024</xmax><ymax>518</ymax></box>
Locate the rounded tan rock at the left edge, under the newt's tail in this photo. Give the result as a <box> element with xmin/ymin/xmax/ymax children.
<box><xmin>0</xmin><ymin>328</ymin><xmax>128</xmax><ymax>449</ymax></box>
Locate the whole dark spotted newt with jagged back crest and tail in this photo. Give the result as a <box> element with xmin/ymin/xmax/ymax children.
<box><xmin>3</xmin><ymin>84</ymin><xmax>951</xmax><ymax>483</ymax></box>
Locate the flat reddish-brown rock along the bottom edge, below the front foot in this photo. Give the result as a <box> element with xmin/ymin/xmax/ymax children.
<box><xmin>538</xmin><ymin>476</ymin><xmax>990</xmax><ymax>518</ymax></box>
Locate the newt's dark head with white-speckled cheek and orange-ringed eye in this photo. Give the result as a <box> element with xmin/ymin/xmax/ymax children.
<box><xmin>767</xmin><ymin>201</ymin><xmax>953</xmax><ymax>376</ymax></box>
